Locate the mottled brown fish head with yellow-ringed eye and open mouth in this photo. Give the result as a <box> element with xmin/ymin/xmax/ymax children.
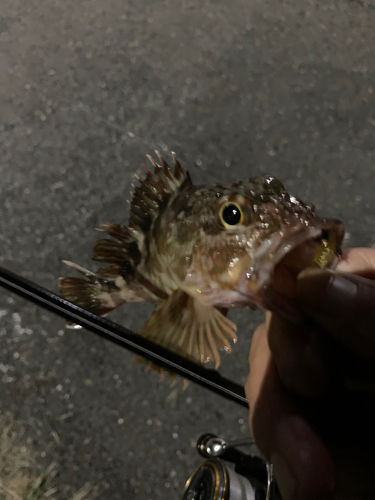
<box><xmin>186</xmin><ymin>176</ymin><xmax>344</xmax><ymax>313</ymax></box>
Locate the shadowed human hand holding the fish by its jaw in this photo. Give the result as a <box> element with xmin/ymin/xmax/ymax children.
<box><xmin>245</xmin><ymin>249</ymin><xmax>375</xmax><ymax>500</ymax></box>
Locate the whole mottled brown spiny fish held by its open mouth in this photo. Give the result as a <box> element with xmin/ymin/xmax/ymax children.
<box><xmin>60</xmin><ymin>151</ymin><xmax>345</xmax><ymax>369</ymax></box>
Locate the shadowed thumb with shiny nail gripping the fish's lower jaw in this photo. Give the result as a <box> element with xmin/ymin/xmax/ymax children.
<box><xmin>296</xmin><ymin>269</ymin><xmax>375</xmax><ymax>359</ymax></box>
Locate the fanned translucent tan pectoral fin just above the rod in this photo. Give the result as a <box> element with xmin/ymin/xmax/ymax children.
<box><xmin>139</xmin><ymin>289</ymin><xmax>237</xmax><ymax>368</ymax></box>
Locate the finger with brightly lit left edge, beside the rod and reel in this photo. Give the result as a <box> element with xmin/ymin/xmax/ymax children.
<box><xmin>245</xmin><ymin>325</ymin><xmax>334</xmax><ymax>500</ymax></box>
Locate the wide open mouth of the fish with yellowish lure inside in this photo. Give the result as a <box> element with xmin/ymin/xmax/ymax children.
<box><xmin>247</xmin><ymin>219</ymin><xmax>345</xmax><ymax>318</ymax></box>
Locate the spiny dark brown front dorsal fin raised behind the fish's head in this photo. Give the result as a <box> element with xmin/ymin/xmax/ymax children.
<box><xmin>129</xmin><ymin>151</ymin><xmax>192</xmax><ymax>234</ymax></box>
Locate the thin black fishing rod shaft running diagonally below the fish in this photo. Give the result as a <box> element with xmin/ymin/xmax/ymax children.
<box><xmin>0</xmin><ymin>267</ymin><xmax>248</xmax><ymax>408</ymax></box>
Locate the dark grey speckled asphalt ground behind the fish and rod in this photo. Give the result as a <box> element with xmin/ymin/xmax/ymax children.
<box><xmin>0</xmin><ymin>0</ymin><xmax>375</xmax><ymax>500</ymax></box>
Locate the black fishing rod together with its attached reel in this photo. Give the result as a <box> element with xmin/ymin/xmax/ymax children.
<box><xmin>0</xmin><ymin>267</ymin><xmax>281</xmax><ymax>500</ymax></box>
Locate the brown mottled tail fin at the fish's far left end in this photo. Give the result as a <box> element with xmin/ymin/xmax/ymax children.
<box><xmin>60</xmin><ymin>261</ymin><xmax>125</xmax><ymax>316</ymax></box>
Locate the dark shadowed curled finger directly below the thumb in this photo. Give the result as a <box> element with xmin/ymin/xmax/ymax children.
<box><xmin>267</xmin><ymin>308</ymin><xmax>375</xmax><ymax>402</ymax></box>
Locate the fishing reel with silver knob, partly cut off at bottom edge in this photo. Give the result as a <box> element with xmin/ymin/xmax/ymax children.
<box><xmin>181</xmin><ymin>434</ymin><xmax>281</xmax><ymax>500</ymax></box>
